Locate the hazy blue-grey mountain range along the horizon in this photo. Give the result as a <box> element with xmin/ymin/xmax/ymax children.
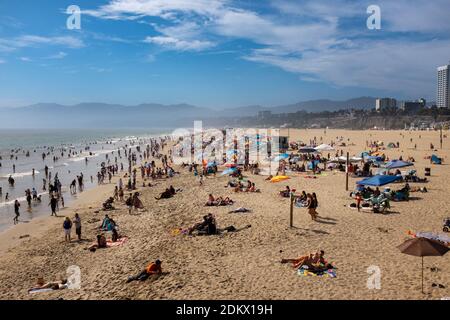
<box><xmin>0</xmin><ymin>97</ymin><xmax>376</xmax><ymax>128</ymax></box>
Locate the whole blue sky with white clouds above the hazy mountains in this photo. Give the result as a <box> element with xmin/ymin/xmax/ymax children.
<box><xmin>0</xmin><ymin>0</ymin><xmax>450</xmax><ymax>108</ymax></box>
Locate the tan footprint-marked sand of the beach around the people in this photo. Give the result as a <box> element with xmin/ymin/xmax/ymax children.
<box><xmin>0</xmin><ymin>129</ymin><xmax>450</xmax><ymax>300</ymax></box>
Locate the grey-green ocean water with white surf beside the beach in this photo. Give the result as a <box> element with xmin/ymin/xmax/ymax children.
<box><xmin>0</xmin><ymin>129</ymin><xmax>169</xmax><ymax>231</ymax></box>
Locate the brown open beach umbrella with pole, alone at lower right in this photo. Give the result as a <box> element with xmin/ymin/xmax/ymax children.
<box><xmin>397</xmin><ymin>238</ymin><xmax>449</xmax><ymax>293</ymax></box>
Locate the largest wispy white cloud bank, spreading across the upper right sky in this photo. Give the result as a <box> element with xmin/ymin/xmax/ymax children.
<box><xmin>85</xmin><ymin>0</ymin><xmax>450</xmax><ymax>95</ymax></box>
